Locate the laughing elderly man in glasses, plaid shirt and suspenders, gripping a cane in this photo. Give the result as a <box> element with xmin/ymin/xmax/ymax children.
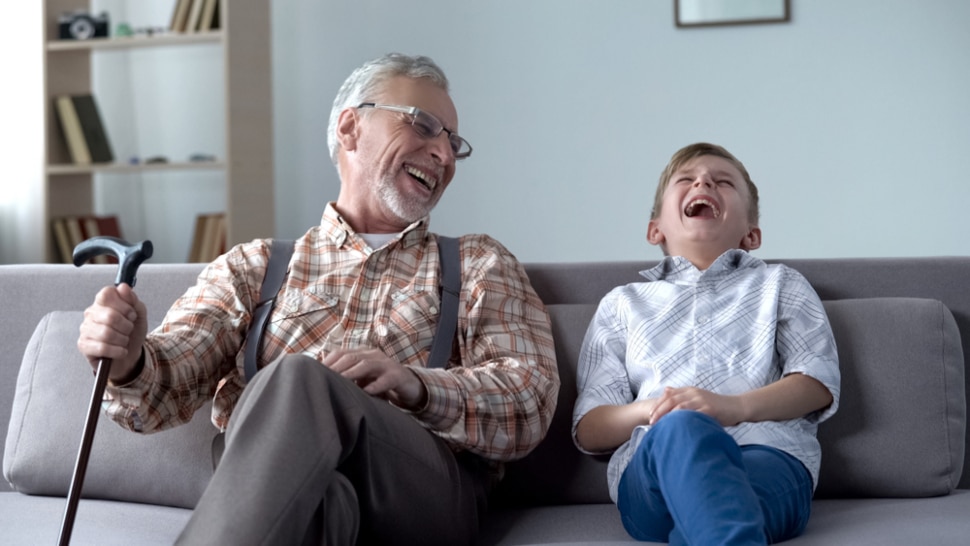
<box><xmin>78</xmin><ymin>54</ymin><xmax>559</xmax><ymax>545</ymax></box>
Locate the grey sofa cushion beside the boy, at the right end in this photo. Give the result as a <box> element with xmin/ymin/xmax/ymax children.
<box><xmin>816</xmin><ymin>298</ymin><xmax>967</xmax><ymax>498</ymax></box>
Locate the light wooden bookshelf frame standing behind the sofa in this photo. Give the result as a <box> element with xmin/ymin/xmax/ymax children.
<box><xmin>38</xmin><ymin>0</ymin><xmax>274</xmax><ymax>261</ymax></box>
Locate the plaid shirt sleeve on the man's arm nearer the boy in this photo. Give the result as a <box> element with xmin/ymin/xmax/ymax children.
<box><xmin>414</xmin><ymin>235</ymin><xmax>559</xmax><ymax>461</ymax></box>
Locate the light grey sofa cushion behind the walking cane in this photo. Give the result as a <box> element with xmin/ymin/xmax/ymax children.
<box><xmin>3</xmin><ymin>311</ymin><xmax>217</xmax><ymax>508</ymax></box>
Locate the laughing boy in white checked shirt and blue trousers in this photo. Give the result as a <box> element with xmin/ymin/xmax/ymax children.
<box><xmin>573</xmin><ymin>143</ymin><xmax>840</xmax><ymax>545</ymax></box>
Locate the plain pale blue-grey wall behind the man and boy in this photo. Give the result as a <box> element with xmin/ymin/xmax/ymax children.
<box><xmin>273</xmin><ymin>0</ymin><xmax>970</xmax><ymax>261</ymax></box>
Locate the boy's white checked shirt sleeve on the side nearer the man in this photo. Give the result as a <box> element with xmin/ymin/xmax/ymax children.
<box><xmin>572</xmin><ymin>289</ymin><xmax>634</xmax><ymax>454</ymax></box>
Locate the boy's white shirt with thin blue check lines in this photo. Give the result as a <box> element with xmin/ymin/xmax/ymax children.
<box><xmin>573</xmin><ymin>250</ymin><xmax>841</xmax><ymax>502</ymax></box>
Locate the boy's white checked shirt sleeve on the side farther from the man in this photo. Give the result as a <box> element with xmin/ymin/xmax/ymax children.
<box><xmin>775</xmin><ymin>267</ymin><xmax>842</xmax><ymax>423</ymax></box>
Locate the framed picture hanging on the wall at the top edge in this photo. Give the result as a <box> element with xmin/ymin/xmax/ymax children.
<box><xmin>674</xmin><ymin>0</ymin><xmax>791</xmax><ymax>27</ymax></box>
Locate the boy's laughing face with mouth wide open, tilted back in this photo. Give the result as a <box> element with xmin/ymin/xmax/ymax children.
<box><xmin>647</xmin><ymin>155</ymin><xmax>761</xmax><ymax>267</ymax></box>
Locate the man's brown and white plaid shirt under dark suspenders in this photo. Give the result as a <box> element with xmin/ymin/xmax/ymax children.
<box><xmin>106</xmin><ymin>204</ymin><xmax>559</xmax><ymax>461</ymax></box>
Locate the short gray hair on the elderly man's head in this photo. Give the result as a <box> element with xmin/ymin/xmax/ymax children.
<box><xmin>327</xmin><ymin>53</ymin><xmax>448</xmax><ymax>165</ymax></box>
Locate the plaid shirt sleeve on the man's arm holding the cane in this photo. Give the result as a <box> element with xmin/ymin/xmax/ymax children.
<box><xmin>105</xmin><ymin>242</ymin><xmax>269</xmax><ymax>432</ymax></box>
